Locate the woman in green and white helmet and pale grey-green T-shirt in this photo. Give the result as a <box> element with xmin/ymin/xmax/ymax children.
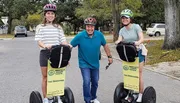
<box><xmin>115</xmin><ymin>9</ymin><xmax>145</xmax><ymax>102</ymax></box>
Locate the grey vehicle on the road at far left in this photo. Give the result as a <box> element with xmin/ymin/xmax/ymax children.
<box><xmin>14</xmin><ymin>25</ymin><xmax>27</xmax><ymax>37</ymax></box>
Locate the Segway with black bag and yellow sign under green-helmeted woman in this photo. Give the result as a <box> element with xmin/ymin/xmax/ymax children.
<box><xmin>114</xmin><ymin>42</ymin><xmax>156</xmax><ymax>103</ymax></box>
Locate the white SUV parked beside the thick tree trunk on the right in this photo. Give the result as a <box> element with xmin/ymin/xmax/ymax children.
<box><xmin>146</xmin><ymin>23</ymin><xmax>165</xmax><ymax>36</ymax></box>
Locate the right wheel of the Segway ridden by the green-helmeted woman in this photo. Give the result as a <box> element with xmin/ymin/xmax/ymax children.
<box><xmin>142</xmin><ymin>86</ymin><xmax>156</xmax><ymax>103</ymax></box>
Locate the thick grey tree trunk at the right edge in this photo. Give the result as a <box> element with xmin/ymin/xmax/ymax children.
<box><xmin>162</xmin><ymin>0</ymin><xmax>180</xmax><ymax>50</ymax></box>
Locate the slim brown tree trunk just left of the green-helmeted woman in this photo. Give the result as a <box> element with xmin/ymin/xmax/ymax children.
<box><xmin>111</xmin><ymin>0</ymin><xmax>120</xmax><ymax>41</ymax></box>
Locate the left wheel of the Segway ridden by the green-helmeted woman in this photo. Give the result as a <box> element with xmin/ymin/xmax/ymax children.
<box><xmin>114</xmin><ymin>83</ymin><xmax>129</xmax><ymax>103</ymax></box>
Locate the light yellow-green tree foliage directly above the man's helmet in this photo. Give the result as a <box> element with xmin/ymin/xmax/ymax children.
<box><xmin>76</xmin><ymin>0</ymin><xmax>112</xmax><ymax>20</ymax></box>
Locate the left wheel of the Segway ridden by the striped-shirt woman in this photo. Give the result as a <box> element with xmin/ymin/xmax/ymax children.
<box><xmin>29</xmin><ymin>91</ymin><xmax>43</xmax><ymax>103</ymax></box>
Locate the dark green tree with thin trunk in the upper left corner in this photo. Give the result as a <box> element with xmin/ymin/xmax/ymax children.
<box><xmin>0</xmin><ymin>0</ymin><xmax>39</xmax><ymax>33</ymax></box>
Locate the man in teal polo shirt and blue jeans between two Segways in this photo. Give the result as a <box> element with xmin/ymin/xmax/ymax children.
<box><xmin>70</xmin><ymin>17</ymin><xmax>113</xmax><ymax>103</ymax></box>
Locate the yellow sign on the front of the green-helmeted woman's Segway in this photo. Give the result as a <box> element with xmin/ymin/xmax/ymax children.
<box><xmin>122</xmin><ymin>58</ymin><xmax>139</xmax><ymax>92</ymax></box>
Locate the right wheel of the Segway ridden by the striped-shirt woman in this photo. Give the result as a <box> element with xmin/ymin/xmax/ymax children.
<box><xmin>61</xmin><ymin>87</ymin><xmax>75</xmax><ymax>103</ymax></box>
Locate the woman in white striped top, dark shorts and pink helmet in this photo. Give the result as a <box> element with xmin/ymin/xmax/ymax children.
<box><xmin>35</xmin><ymin>4</ymin><xmax>68</xmax><ymax>103</ymax></box>
